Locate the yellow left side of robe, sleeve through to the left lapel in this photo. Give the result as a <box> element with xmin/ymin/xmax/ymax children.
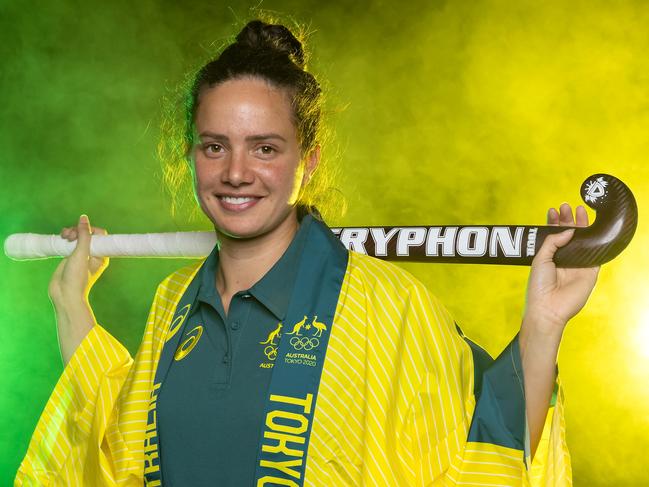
<box><xmin>14</xmin><ymin>271</ymin><xmax>176</xmax><ymax>487</ymax></box>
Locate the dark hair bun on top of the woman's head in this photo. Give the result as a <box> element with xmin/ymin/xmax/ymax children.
<box><xmin>237</xmin><ymin>20</ymin><xmax>304</xmax><ymax>69</ymax></box>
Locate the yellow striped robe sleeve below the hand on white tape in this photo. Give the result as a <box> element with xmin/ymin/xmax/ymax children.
<box><xmin>14</xmin><ymin>325</ymin><xmax>133</xmax><ymax>486</ymax></box>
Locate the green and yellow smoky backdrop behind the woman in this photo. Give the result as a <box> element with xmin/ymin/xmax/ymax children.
<box><xmin>0</xmin><ymin>0</ymin><xmax>649</xmax><ymax>486</ymax></box>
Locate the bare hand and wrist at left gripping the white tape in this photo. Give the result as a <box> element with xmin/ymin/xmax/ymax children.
<box><xmin>48</xmin><ymin>215</ymin><xmax>108</xmax><ymax>364</ymax></box>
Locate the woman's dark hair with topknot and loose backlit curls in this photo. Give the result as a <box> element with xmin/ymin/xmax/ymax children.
<box><xmin>159</xmin><ymin>20</ymin><xmax>340</xmax><ymax>221</ymax></box>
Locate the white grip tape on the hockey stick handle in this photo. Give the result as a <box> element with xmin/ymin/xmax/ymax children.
<box><xmin>4</xmin><ymin>232</ymin><xmax>216</xmax><ymax>260</ymax></box>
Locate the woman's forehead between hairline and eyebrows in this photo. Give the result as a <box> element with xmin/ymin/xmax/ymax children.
<box><xmin>195</xmin><ymin>78</ymin><xmax>295</xmax><ymax>136</ymax></box>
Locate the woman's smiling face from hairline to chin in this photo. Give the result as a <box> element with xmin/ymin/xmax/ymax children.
<box><xmin>193</xmin><ymin>78</ymin><xmax>312</xmax><ymax>242</ymax></box>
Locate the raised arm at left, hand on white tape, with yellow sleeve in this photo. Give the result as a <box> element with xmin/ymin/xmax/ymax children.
<box><xmin>15</xmin><ymin>215</ymin><xmax>133</xmax><ymax>485</ymax></box>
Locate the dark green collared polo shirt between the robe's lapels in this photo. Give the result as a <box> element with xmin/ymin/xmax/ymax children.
<box><xmin>157</xmin><ymin>218</ymin><xmax>311</xmax><ymax>487</ymax></box>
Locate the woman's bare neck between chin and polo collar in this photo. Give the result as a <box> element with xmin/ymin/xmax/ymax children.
<box><xmin>216</xmin><ymin>214</ymin><xmax>299</xmax><ymax>313</ymax></box>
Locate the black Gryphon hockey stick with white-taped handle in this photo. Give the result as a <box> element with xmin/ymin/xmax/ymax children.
<box><xmin>5</xmin><ymin>174</ymin><xmax>638</xmax><ymax>267</ymax></box>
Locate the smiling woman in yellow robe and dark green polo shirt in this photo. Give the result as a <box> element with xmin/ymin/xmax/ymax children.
<box><xmin>17</xmin><ymin>17</ymin><xmax>597</xmax><ymax>486</ymax></box>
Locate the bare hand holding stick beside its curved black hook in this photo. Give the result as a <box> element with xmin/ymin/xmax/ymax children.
<box><xmin>523</xmin><ymin>203</ymin><xmax>599</xmax><ymax>336</ymax></box>
